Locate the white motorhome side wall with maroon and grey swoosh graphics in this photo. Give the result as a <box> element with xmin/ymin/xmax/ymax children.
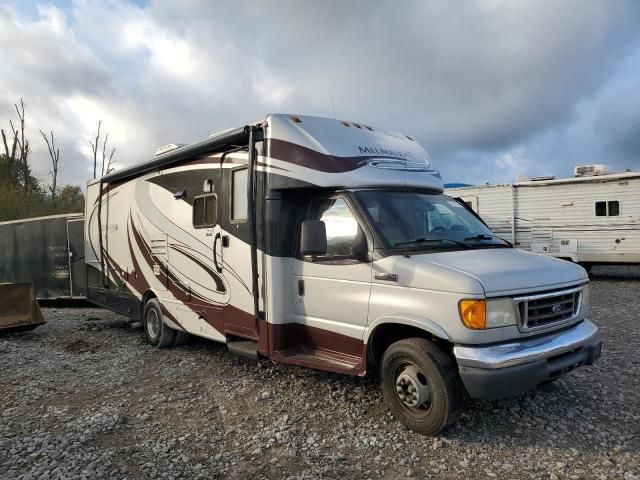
<box><xmin>86</xmin><ymin>161</ymin><xmax>255</xmax><ymax>341</ymax></box>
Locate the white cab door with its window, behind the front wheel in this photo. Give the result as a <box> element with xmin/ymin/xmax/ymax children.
<box><xmin>290</xmin><ymin>196</ymin><xmax>372</xmax><ymax>340</ymax></box>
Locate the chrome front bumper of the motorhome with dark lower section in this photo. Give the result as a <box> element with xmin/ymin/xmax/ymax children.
<box><xmin>453</xmin><ymin>320</ymin><xmax>602</xmax><ymax>399</ymax></box>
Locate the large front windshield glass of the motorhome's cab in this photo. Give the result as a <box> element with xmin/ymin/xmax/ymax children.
<box><xmin>355</xmin><ymin>190</ymin><xmax>508</xmax><ymax>249</ymax></box>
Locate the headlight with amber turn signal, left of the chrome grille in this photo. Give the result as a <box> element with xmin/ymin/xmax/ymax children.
<box><xmin>459</xmin><ymin>298</ymin><xmax>518</xmax><ymax>330</ymax></box>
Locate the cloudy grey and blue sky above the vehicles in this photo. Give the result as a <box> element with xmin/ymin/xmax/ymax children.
<box><xmin>0</xmin><ymin>0</ymin><xmax>640</xmax><ymax>188</ymax></box>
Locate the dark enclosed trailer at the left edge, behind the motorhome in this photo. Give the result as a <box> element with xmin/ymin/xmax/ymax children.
<box><xmin>0</xmin><ymin>213</ymin><xmax>87</xmax><ymax>299</ymax></box>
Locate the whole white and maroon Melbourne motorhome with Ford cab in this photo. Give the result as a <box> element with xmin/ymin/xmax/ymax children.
<box><xmin>85</xmin><ymin>114</ymin><xmax>602</xmax><ymax>434</ymax></box>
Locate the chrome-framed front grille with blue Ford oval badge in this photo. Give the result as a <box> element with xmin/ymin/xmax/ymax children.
<box><xmin>514</xmin><ymin>287</ymin><xmax>582</xmax><ymax>330</ymax></box>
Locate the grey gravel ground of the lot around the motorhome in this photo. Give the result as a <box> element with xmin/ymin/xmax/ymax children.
<box><xmin>0</xmin><ymin>268</ymin><xmax>640</xmax><ymax>480</ymax></box>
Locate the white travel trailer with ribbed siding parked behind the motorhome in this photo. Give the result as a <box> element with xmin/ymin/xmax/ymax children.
<box><xmin>446</xmin><ymin>165</ymin><xmax>640</xmax><ymax>270</ymax></box>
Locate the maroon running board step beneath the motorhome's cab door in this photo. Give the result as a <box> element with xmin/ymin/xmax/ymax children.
<box><xmin>274</xmin><ymin>347</ymin><xmax>364</xmax><ymax>375</ymax></box>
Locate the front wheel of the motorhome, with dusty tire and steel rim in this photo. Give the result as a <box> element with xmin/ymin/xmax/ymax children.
<box><xmin>381</xmin><ymin>338</ymin><xmax>463</xmax><ymax>435</ymax></box>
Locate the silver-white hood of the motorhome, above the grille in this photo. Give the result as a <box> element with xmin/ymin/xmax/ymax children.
<box><xmin>406</xmin><ymin>248</ymin><xmax>589</xmax><ymax>296</ymax></box>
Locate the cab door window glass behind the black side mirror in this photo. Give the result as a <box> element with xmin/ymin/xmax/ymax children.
<box><xmin>309</xmin><ymin>198</ymin><xmax>358</xmax><ymax>256</ymax></box>
